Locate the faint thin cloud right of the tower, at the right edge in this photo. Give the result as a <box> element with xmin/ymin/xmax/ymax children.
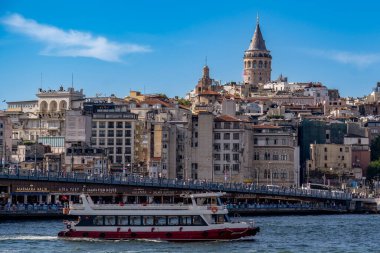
<box><xmin>308</xmin><ymin>50</ymin><xmax>380</xmax><ymax>67</ymax></box>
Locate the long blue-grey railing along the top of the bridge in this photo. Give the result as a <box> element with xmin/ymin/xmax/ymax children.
<box><xmin>0</xmin><ymin>171</ymin><xmax>352</xmax><ymax>200</ymax></box>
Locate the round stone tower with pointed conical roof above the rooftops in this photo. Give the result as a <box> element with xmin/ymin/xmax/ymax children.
<box><xmin>243</xmin><ymin>15</ymin><xmax>272</xmax><ymax>90</ymax></box>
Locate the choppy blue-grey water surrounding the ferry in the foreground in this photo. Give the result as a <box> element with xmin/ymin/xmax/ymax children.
<box><xmin>0</xmin><ymin>215</ymin><xmax>380</xmax><ymax>253</ymax></box>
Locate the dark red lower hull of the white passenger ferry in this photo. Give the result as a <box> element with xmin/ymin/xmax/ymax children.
<box><xmin>58</xmin><ymin>228</ymin><xmax>260</xmax><ymax>241</ymax></box>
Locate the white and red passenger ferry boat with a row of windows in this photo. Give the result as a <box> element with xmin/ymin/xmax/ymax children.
<box><xmin>58</xmin><ymin>193</ymin><xmax>260</xmax><ymax>241</ymax></box>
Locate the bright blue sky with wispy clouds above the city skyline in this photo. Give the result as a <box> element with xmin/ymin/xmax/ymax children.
<box><xmin>0</xmin><ymin>0</ymin><xmax>380</xmax><ymax>109</ymax></box>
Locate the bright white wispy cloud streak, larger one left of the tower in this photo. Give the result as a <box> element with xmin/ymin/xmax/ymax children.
<box><xmin>1</xmin><ymin>14</ymin><xmax>150</xmax><ymax>62</ymax></box>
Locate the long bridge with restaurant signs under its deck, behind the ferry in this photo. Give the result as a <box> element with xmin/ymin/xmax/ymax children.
<box><xmin>0</xmin><ymin>171</ymin><xmax>352</xmax><ymax>202</ymax></box>
